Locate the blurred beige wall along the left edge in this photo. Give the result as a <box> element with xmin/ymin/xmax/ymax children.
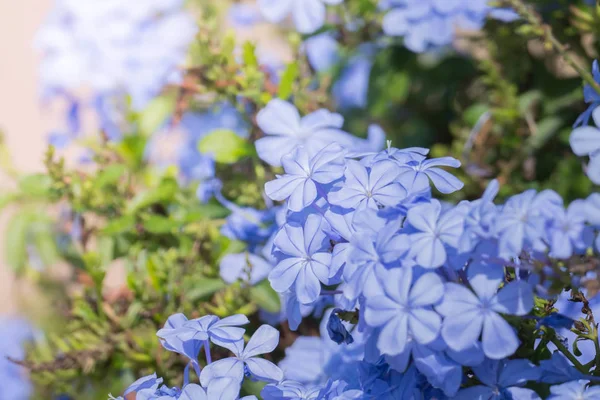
<box><xmin>0</xmin><ymin>0</ymin><xmax>52</xmax><ymax>314</ymax></box>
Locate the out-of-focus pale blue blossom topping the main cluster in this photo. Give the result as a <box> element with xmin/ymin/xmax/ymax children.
<box><xmin>255</xmin><ymin>99</ymin><xmax>383</xmax><ymax>167</ymax></box>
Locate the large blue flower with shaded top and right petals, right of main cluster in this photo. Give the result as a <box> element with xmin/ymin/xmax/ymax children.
<box><xmin>436</xmin><ymin>263</ymin><xmax>533</xmax><ymax>360</ymax></box>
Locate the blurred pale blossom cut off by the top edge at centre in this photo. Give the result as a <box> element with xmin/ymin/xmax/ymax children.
<box><xmin>258</xmin><ymin>0</ymin><xmax>343</xmax><ymax>33</ymax></box>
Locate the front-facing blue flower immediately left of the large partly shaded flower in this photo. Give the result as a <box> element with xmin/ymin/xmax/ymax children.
<box><xmin>364</xmin><ymin>268</ymin><xmax>444</xmax><ymax>355</ymax></box>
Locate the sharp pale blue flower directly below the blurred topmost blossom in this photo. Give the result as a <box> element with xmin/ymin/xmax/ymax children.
<box><xmin>265</xmin><ymin>143</ymin><xmax>345</xmax><ymax>212</ymax></box>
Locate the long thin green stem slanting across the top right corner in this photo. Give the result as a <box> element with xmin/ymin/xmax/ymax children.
<box><xmin>504</xmin><ymin>0</ymin><xmax>600</xmax><ymax>94</ymax></box>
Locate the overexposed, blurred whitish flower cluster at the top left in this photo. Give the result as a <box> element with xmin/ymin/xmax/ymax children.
<box><xmin>36</xmin><ymin>0</ymin><xmax>196</xmax><ymax>143</ymax></box>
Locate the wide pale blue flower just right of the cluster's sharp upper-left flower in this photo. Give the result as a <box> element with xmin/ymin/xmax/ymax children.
<box><xmin>327</xmin><ymin>160</ymin><xmax>406</xmax><ymax>210</ymax></box>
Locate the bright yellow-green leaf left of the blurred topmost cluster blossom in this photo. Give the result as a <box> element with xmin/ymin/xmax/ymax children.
<box><xmin>198</xmin><ymin>129</ymin><xmax>254</xmax><ymax>164</ymax></box>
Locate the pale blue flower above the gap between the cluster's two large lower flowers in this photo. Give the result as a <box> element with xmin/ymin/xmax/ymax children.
<box><xmin>406</xmin><ymin>200</ymin><xmax>464</xmax><ymax>268</ymax></box>
